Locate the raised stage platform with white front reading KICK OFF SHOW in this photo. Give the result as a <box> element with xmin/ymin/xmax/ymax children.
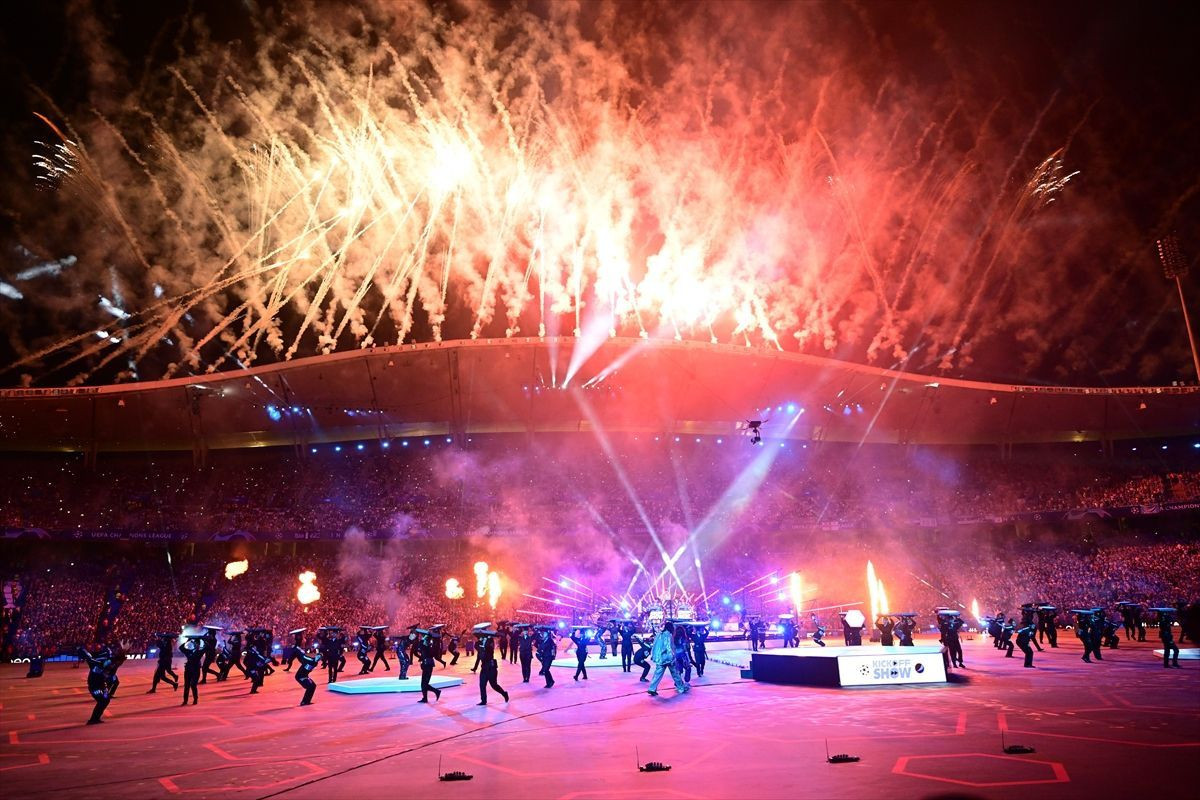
<box><xmin>750</xmin><ymin>644</ymin><xmax>946</xmax><ymax>686</ymax></box>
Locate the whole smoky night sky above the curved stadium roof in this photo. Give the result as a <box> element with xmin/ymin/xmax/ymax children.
<box><xmin>0</xmin><ymin>0</ymin><xmax>1200</xmax><ymax>386</ymax></box>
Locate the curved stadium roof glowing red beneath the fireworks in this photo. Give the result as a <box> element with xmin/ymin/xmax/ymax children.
<box><xmin>0</xmin><ymin>337</ymin><xmax>1200</xmax><ymax>452</ymax></box>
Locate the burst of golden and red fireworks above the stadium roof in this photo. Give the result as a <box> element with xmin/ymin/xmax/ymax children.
<box><xmin>8</xmin><ymin>4</ymin><xmax>1099</xmax><ymax>383</ymax></box>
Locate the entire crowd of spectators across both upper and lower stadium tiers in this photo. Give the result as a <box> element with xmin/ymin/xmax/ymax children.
<box><xmin>0</xmin><ymin>434</ymin><xmax>1200</xmax><ymax>655</ymax></box>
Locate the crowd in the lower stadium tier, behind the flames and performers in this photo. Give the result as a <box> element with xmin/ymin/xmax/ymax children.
<box><xmin>7</xmin><ymin>536</ymin><xmax>1200</xmax><ymax>656</ymax></box>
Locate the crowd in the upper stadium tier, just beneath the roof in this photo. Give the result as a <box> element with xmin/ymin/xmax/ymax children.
<box><xmin>0</xmin><ymin>434</ymin><xmax>1200</xmax><ymax>539</ymax></box>
